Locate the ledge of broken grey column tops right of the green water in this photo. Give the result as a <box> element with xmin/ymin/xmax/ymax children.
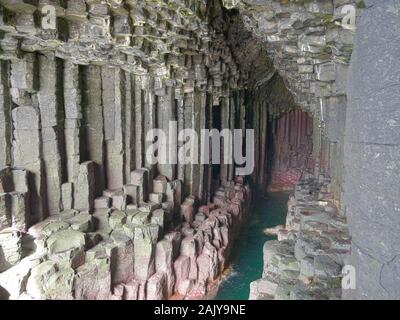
<box><xmin>250</xmin><ymin>174</ymin><xmax>351</xmax><ymax>300</ymax></box>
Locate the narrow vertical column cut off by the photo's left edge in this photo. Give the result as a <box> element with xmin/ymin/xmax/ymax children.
<box><xmin>0</xmin><ymin>61</ymin><xmax>12</xmax><ymax>167</ymax></box>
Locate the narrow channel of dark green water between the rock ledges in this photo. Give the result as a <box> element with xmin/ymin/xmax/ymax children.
<box><xmin>215</xmin><ymin>193</ymin><xmax>289</xmax><ymax>300</ymax></box>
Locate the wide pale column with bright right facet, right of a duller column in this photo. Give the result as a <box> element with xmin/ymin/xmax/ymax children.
<box><xmin>101</xmin><ymin>67</ymin><xmax>125</xmax><ymax>190</ymax></box>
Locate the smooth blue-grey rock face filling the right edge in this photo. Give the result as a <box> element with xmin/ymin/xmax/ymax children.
<box><xmin>343</xmin><ymin>0</ymin><xmax>400</xmax><ymax>299</ymax></box>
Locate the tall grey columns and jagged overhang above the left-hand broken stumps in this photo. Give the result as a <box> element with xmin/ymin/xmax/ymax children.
<box><xmin>0</xmin><ymin>1</ymin><xmax>245</xmax><ymax>228</ymax></box>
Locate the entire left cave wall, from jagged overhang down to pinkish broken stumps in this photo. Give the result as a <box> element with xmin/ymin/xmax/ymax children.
<box><xmin>0</xmin><ymin>0</ymin><xmax>251</xmax><ymax>300</ymax></box>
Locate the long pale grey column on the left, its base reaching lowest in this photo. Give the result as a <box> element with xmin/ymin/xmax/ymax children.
<box><xmin>37</xmin><ymin>55</ymin><xmax>65</xmax><ymax>215</ymax></box>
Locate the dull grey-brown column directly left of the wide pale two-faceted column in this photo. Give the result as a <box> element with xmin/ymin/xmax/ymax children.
<box><xmin>81</xmin><ymin>65</ymin><xmax>106</xmax><ymax>196</ymax></box>
